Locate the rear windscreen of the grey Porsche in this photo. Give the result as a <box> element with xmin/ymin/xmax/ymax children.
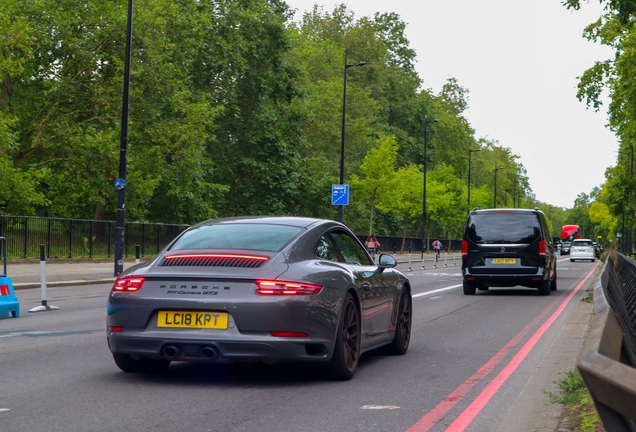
<box><xmin>171</xmin><ymin>224</ymin><xmax>302</xmax><ymax>252</ymax></box>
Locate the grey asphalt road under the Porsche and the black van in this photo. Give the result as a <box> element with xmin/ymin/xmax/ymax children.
<box><xmin>0</xmin><ymin>257</ymin><xmax>595</xmax><ymax>432</ymax></box>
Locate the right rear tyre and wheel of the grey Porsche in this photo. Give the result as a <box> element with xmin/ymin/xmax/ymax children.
<box><xmin>327</xmin><ymin>293</ymin><xmax>360</xmax><ymax>381</ymax></box>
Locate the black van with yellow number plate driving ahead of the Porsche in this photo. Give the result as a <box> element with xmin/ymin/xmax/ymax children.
<box><xmin>462</xmin><ymin>208</ymin><xmax>557</xmax><ymax>295</ymax></box>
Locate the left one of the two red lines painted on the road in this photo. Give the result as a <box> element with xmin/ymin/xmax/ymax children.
<box><xmin>407</xmin><ymin>266</ymin><xmax>589</xmax><ymax>432</ymax></box>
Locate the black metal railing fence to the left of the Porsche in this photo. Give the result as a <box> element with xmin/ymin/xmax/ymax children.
<box><xmin>0</xmin><ymin>216</ymin><xmax>189</xmax><ymax>258</ymax></box>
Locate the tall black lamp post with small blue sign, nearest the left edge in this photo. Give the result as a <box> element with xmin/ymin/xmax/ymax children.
<box><xmin>115</xmin><ymin>0</ymin><xmax>132</xmax><ymax>276</ymax></box>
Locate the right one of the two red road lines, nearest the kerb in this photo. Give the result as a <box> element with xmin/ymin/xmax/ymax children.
<box><xmin>446</xmin><ymin>267</ymin><xmax>596</xmax><ymax>432</ymax></box>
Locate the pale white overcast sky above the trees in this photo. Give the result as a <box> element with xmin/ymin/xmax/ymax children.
<box><xmin>286</xmin><ymin>0</ymin><xmax>618</xmax><ymax>208</ymax></box>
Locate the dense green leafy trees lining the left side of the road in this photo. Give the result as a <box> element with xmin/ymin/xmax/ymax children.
<box><xmin>0</xmin><ymin>0</ymin><xmax>544</xmax><ymax>237</ymax></box>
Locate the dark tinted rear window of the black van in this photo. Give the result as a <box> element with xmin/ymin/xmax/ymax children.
<box><xmin>466</xmin><ymin>212</ymin><xmax>541</xmax><ymax>244</ymax></box>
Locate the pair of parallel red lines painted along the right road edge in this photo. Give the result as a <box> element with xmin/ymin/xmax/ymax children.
<box><xmin>407</xmin><ymin>268</ymin><xmax>595</xmax><ymax>432</ymax></box>
